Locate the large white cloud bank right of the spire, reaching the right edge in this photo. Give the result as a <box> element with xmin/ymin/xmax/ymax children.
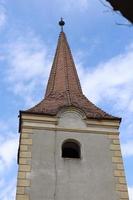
<box><xmin>78</xmin><ymin>43</ymin><xmax>133</xmax><ymax>112</ymax></box>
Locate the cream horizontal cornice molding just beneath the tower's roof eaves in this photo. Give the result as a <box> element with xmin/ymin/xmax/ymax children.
<box><xmin>22</xmin><ymin>111</ymin><xmax>119</xmax><ymax>135</ymax></box>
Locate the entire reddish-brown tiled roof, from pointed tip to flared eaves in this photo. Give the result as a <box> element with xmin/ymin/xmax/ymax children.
<box><xmin>23</xmin><ymin>31</ymin><xmax>120</xmax><ymax>120</ymax></box>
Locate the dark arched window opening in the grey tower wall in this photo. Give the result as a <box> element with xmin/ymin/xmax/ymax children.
<box><xmin>62</xmin><ymin>139</ymin><xmax>80</xmax><ymax>158</ymax></box>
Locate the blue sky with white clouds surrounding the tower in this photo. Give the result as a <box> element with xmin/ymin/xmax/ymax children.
<box><xmin>0</xmin><ymin>0</ymin><xmax>133</xmax><ymax>200</ymax></box>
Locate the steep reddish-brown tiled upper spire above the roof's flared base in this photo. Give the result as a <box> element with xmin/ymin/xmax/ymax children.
<box><xmin>45</xmin><ymin>31</ymin><xmax>82</xmax><ymax>104</ymax></box>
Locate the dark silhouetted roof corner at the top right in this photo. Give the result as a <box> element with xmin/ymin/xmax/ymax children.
<box><xmin>106</xmin><ymin>0</ymin><xmax>133</xmax><ymax>24</ymax></box>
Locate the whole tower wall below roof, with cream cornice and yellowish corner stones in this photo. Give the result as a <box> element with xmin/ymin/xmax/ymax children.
<box><xmin>17</xmin><ymin>110</ymin><xmax>128</xmax><ymax>200</ymax></box>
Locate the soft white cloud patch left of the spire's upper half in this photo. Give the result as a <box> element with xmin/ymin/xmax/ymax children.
<box><xmin>6</xmin><ymin>38</ymin><xmax>47</xmax><ymax>81</ymax></box>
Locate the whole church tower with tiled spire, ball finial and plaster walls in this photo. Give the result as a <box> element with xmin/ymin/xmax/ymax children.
<box><xmin>16</xmin><ymin>20</ymin><xmax>128</xmax><ymax>200</ymax></box>
